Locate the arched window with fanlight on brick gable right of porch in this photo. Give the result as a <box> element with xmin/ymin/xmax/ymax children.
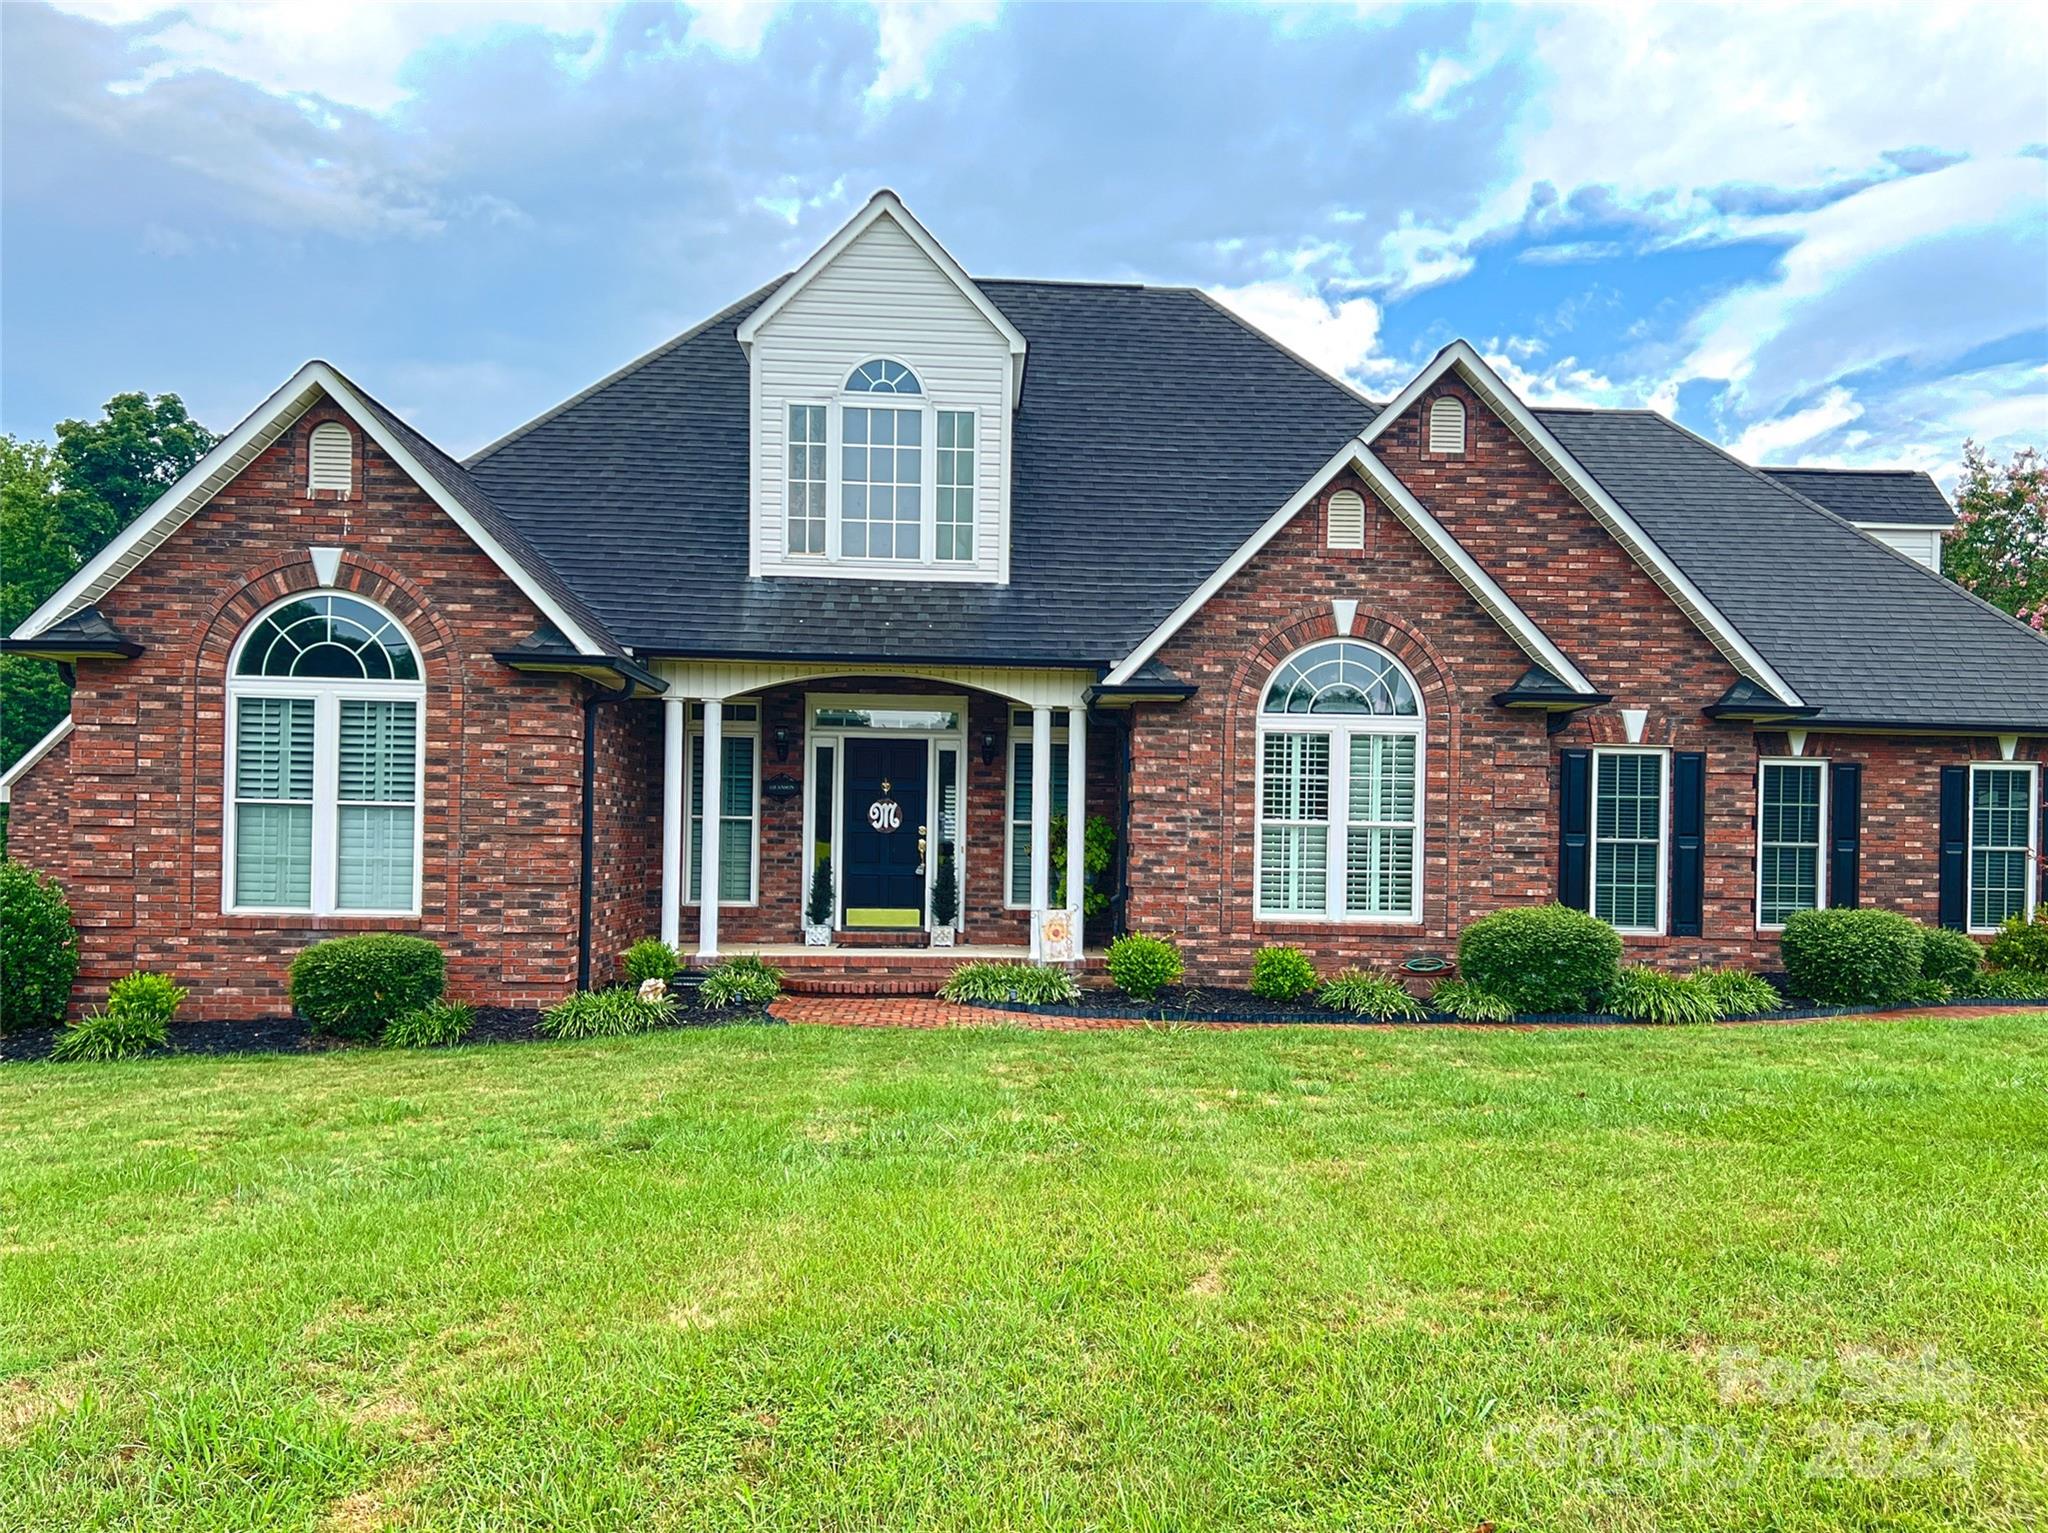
<box><xmin>1257</xmin><ymin>639</ymin><xmax>1423</xmax><ymax>921</ymax></box>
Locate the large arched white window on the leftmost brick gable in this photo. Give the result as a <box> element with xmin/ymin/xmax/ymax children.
<box><xmin>223</xmin><ymin>592</ymin><xmax>426</xmax><ymax>915</ymax></box>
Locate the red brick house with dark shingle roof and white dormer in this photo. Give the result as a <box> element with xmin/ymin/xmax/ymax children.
<box><xmin>0</xmin><ymin>192</ymin><xmax>2048</xmax><ymax>1015</ymax></box>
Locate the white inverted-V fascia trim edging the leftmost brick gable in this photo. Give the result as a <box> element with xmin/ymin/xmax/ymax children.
<box><xmin>14</xmin><ymin>362</ymin><xmax>606</xmax><ymax>655</ymax></box>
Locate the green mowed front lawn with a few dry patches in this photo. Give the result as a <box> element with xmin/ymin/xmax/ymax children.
<box><xmin>0</xmin><ymin>1017</ymin><xmax>2048</xmax><ymax>1533</ymax></box>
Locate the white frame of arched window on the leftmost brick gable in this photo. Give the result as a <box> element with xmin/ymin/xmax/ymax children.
<box><xmin>221</xmin><ymin>587</ymin><xmax>426</xmax><ymax>921</ymax></box>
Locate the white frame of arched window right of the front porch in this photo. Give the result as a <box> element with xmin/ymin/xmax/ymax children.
<box><xmin>1251</xmin><ymin>639</ymin><xmax>1430</xmax><ymax>927</ymax></box>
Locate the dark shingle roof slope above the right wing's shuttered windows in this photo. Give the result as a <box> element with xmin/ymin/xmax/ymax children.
<box><xmin>1536</xmin><ymin>409</ymin><xmax>2048</xmax><ymax>727</ymax></box>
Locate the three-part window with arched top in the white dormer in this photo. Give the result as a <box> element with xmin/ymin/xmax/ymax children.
<box><xmin>782</xmin><ymin>356</ymin><xmax>975</xmax><ymax>565</ymax></box>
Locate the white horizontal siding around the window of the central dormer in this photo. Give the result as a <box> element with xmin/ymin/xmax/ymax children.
<box><xmin>752</xmin><ymin>217</ymin><xmax>1012</xmax><ymax>581</ymax></box>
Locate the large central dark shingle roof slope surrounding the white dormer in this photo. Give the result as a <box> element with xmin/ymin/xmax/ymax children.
<box><xmin>469</xmin><ymin>280</ymin><xmax>1372</xmax><ymax>665</ymax></box>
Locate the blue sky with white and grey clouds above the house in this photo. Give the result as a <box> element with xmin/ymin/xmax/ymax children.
<box><xmin>0</xmin><ymin>0</ymin><xmax>2048</xmax><ymax>479</ymax></box>
